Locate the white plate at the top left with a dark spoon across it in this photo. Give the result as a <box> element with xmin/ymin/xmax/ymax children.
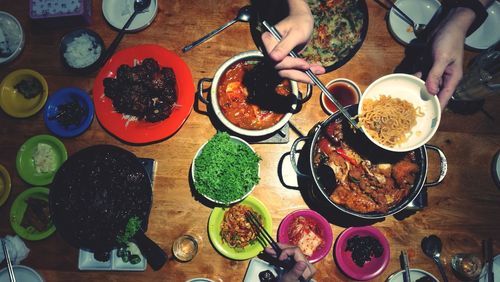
<box><xmin>102</xmin><ymin>0</ymin><xmax>158</xmax><ymax>31</ymax></box>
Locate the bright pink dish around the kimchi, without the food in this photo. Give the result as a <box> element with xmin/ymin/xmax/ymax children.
<box><xmin>278</xmin><ymin>210</ymin><xmax>333</xmax><ymax>263</ymax></box>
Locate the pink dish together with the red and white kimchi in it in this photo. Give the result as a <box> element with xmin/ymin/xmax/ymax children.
<box><xmin>278</xmin><ymin>209</ymin><xmax>333</xmax><ymax>263</ymax></box>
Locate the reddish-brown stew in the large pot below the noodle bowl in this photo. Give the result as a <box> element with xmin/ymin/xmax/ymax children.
<box><xmin>313</xmin><ymin>119</ymin><xmax>420</xmax><ymax>213</ymax></box>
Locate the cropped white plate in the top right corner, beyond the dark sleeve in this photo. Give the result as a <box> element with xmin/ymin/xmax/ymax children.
<box><xmin>465</xmin><ymin>1</ymin><xmax>500</xmax><ymax>50</ymax></box>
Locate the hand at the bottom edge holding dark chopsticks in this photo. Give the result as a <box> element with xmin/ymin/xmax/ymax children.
<box><xmin>266</xmin><ymin>243</ymin><xmax>316</xmax><ymax>282</ymax></box>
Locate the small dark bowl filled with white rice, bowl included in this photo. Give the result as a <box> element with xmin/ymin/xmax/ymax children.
<box><xmin>59</xmin><ymin>28</ymin><xmax>104</xmax><ymax>73</ymax></box>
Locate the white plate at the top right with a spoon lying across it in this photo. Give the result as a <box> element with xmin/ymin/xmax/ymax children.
<box><xmin>387</xmin><ymin>0</ymin><xmax>441</xmax><ymax>45</ymax></box>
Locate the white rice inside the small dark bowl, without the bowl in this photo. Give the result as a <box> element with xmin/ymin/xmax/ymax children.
<box><xmin>64</xmin><ymin>33</ymin><xmax>101</xmax><ymax>68</ymax></box>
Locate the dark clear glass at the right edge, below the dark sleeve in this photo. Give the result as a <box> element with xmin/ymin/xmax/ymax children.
<box><xmin>452</xmin><ymin>43</ymin><xmax>500</xmax><ymax>101</ymax></box>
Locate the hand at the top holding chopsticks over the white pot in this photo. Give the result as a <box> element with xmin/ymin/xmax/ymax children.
<box><xmin>262</xmin><ymin>0</ymin><xmax>325</xmax><ymax>83</ymax></box>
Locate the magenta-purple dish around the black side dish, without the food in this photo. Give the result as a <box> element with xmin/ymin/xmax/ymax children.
<box><xmin>334</xmin><ymin>226</ymin><xmax>391</xmax><ymax>280</ymax></box>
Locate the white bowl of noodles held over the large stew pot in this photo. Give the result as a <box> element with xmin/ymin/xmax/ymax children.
<box><xmin>358</xmin><ymin>73</ymin><xmax>441</xmax><ymax>152</ymax></box>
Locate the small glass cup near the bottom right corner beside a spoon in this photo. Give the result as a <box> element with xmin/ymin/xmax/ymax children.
<box><xmin>451</xmin><ymin>253</ymin><xmax>483</xmax><ymax>281</ymax></box>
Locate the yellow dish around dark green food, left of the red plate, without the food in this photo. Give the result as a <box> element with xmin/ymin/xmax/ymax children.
<box><xmin>0</xmin><ymin>69</ymin><xmax>49</xmax><ymax>118</ymax></box>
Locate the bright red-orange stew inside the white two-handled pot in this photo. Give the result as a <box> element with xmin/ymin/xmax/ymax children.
<box><xmin>217</xmin><ymin>61</ymin><xmax>292</xmax><ymax>130</ymax></box>
